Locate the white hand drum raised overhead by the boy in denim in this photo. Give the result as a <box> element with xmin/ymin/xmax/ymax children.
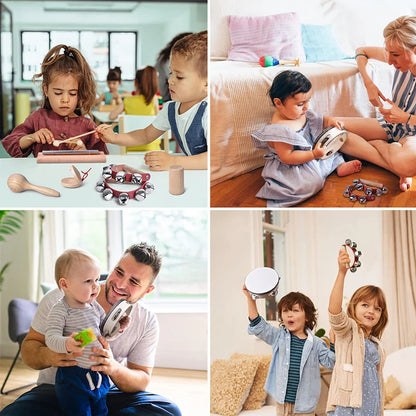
<box><xmin>245</xmin><ymin>267</ymin><xmax>280</xmax><ymax>299</ymax></box>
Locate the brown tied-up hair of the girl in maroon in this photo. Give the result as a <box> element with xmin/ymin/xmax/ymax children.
<box><xmin>33</xmin><ymin>45</ymin><xmax>96</xmax><ymax>116</ymax></box>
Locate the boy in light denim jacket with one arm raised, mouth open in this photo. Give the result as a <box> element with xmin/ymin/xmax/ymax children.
<box><xmin>243</xmin><ymin>286</ymin><xmax>335</xmax><ymax>416</ymax></box>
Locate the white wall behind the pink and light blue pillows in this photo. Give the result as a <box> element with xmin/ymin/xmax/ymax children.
<box><xmin>209</xmin><ymin>0</ymin><xmax>416</xmax><ymax>57</ymax></box>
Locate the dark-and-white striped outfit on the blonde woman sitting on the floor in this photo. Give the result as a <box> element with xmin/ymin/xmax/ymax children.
<box><xmin>378</xmin><ymin>69</ymin><xmax>416</xmax><ymax>142</ymax></box>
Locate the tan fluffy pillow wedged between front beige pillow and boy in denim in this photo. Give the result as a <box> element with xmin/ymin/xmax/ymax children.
<box><xmin>231</xmin><ymin>352</ymin><xmax>272</xmax><ymax>410</ymax></box>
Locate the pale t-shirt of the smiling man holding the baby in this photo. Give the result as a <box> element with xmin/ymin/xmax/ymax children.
<box><xmin>32</xmin><ymin>288</ymin><xmax>159</xmax><ymax>384</ymax></box>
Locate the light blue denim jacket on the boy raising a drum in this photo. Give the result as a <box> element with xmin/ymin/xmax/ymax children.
<box><xmin>248</xmin><ymin>318</ymin><xmax>335</xmax><ymax>413</ymax></box>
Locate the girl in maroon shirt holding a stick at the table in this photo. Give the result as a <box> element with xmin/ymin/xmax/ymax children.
<box><xmin>1</xmin><ymin>45</ymin><xmax>108</xmax><ymax>157</ymax></box>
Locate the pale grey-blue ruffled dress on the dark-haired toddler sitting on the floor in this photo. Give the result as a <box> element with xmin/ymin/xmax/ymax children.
<box><xmin>251</xmin><ymin>110</ymin><xmax>344</xmax><ymax>207</ymax></box>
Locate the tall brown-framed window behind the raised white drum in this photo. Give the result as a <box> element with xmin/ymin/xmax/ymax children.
<box><xmin>262</xmin><ymin>211</ymin><xmax>286</xmax><ymax>321</ymax></box>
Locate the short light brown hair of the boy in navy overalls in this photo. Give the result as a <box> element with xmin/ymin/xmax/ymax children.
<box><xmin>171</xmin><ymin>30</ymin><xmax>208</xmax><ymax>79</ymax></box>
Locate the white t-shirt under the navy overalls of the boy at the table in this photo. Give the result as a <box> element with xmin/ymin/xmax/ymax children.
<box><xmin>152</xmin><ymin>99</ymin><xmax>208</xmax><ymax>146</ymax></box>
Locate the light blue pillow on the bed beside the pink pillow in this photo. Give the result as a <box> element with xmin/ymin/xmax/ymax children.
<box><xmin>302</xmin><ymin>25</ymin><xmax>348</xmax><ymax>62</ymax></box>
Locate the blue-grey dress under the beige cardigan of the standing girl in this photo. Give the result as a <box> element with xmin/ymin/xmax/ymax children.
<box><xmin>327</xmin><ymin>338</ymin><xmax>381</xmax><ymax>416</ymax></box>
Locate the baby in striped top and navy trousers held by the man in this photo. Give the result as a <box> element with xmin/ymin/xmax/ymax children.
<box><xmin>45</xmin><ymin>249</ymin><xmax>129</xmax><ymax>416</ymax></box>
